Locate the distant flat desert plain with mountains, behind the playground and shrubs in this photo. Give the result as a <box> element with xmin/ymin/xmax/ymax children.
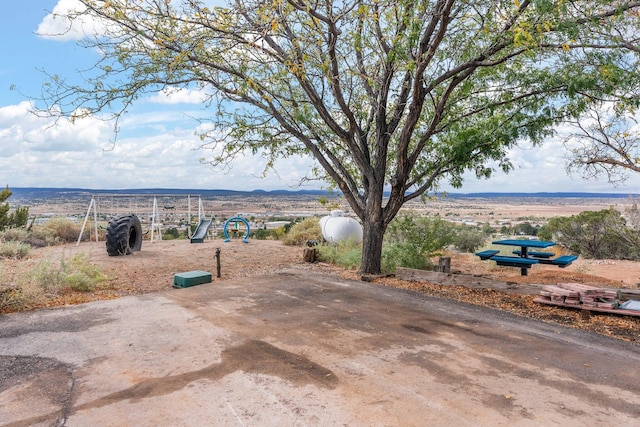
<box><xmin>9</xmin><ymin>188</ymin><xmax>640</xmax><ymax>237</ymax></box>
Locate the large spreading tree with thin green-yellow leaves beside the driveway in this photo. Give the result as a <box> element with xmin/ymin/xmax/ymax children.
<box><xmin>44</xmin><ymin>0</ymin><xmax>640</xmax><ymax>273</ymax></box>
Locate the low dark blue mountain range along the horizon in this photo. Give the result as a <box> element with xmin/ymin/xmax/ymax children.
<box><xmin>9</xmin><ymin>187</ymin><xmax>640</xmax><ymax>199</ymax></box>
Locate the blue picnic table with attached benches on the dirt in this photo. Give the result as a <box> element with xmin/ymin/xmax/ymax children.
<box><xmin>476</xmin><ymin>239</ymin><xmax>578</xmax><ymax>276</ymax></box>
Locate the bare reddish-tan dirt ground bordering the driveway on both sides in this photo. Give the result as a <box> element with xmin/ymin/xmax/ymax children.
<box><xmin>3</xmin><ymin>240</ymin><xmax>640</xmax><ymax>342</ymax></box>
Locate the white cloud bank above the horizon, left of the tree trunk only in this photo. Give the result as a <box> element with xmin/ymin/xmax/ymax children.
<box><xmin>0</xmin><ymin>102</ymin><xmax>312</xmax><ymax>190</ymax></box>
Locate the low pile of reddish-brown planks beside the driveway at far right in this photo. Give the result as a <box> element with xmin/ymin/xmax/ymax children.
<box><xmin>534</xmin><ymin>283</ymin><xmax>640</xmax><ymax>317</ymax></box>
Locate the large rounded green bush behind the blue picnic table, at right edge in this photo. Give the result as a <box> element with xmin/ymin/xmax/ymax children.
<box><xmin>538</xmin><ymin>208</ymin><xmax>640</xmax><ymax>260</ymax></box>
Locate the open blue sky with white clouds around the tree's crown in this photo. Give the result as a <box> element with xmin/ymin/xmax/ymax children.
<box><xmin>0</xmin><ymin>0</ymin><xmax>640</xmax><ymax>193</ymax></box>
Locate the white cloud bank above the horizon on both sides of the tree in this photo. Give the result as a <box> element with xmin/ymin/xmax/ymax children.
<box><xmin>0</xmin><ymin>96</ymin><xmax>640</xmax><ymax>193</ymax></box>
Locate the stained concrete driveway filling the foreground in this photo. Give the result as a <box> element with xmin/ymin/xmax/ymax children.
<box><xmin>0</xmin><ymin>266</ymin><xmax>640</xmax><ymax>426</ymax></box>
